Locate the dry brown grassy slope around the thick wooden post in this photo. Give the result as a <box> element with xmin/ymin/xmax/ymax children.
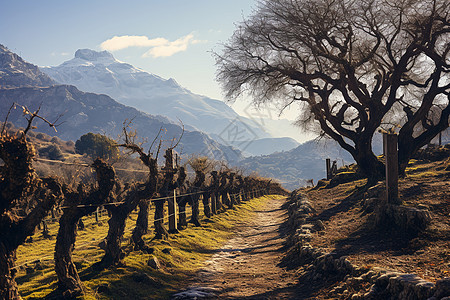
<box><xmin>307</xmin><ymin>160</ymin><xmax>450</xmax><ymax>282</ymax></box>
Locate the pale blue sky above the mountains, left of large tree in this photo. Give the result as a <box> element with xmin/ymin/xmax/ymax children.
<box><xmin>0</xmin><ymin>0</ymin><xmax>256</xmax><ymax>99</ymax></box>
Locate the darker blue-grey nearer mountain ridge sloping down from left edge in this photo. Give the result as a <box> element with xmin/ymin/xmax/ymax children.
<box><xmin>0</xmin><ymin>45</ymin><xmax>241</xmax><ymax>162</ymax></box>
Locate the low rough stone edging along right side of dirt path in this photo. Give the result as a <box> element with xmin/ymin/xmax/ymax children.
<box><xmin>287</xmin><ymin>191</ymin><xmax>450</xmax><ymax>300</ymax></box>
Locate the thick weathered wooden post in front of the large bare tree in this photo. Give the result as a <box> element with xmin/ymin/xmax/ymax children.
<box><xmin>383</xmin><ymin>133</ymin><xmax>400</xmax><ymax>204</ymax></box>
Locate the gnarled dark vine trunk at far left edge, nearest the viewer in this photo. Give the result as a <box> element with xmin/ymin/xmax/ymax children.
<box><xmin>0</xmin><ymin>107</ymin><xmax>62</xmax><ymax>300</ymax></box>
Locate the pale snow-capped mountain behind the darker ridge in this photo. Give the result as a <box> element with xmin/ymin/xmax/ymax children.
<box><xmin>41</xmin><ymin>49</ymin><xmax>299</xmax><ymax>155</ymax></box>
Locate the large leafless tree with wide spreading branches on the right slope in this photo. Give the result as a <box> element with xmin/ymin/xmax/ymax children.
<box><xmin>215</xmin><ymin>0</ymin><xmax>450</xmax><ymax>179</ymax></box>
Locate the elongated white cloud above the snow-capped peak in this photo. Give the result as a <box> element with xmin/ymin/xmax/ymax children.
<box><xmin>100</xmin><ymin>33</ymin><xmax>206</xmax><ymax>58</ymax></box>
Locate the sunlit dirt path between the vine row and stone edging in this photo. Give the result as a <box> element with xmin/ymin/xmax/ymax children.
<box><xmin>175</xmin><ymin>199</ymin><xmax>298</xmax><ymax>299</ymax></box>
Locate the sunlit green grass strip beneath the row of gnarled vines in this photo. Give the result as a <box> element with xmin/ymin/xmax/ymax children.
<box><xmin>16</xmin><ymin>196</ymin><xmax>278</xmax><ymax>299</ymax></box>
